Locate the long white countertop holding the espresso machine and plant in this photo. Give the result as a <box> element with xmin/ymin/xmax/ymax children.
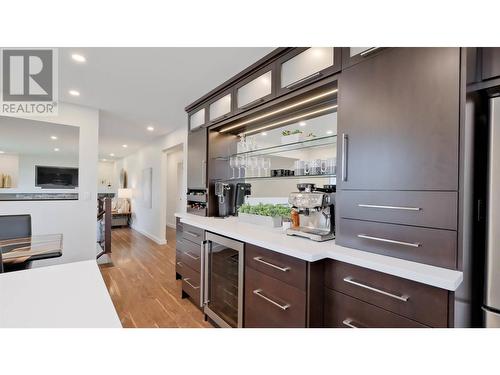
<box><xmin>176</xmin><ymin>214</ymin><xmax>463</xmax><ymax>291</ymax></box>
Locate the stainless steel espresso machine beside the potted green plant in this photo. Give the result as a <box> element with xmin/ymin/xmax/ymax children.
<box><xmin>286</xmin><ymin>184</ymin><xmax>336</xmax><ymax>241</ymax></box>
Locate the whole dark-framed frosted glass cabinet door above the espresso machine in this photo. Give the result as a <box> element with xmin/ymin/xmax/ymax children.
<box><xmin>276</xmin><ymin>47</ymin><xmax>342</xmax><ymax>95</ymax></box>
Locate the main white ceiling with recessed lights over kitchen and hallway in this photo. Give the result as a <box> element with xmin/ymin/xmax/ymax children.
<box><xmin>59</xmin><ymin>47</ymin><xmax>274</xmax><ymax>159</ymax></box>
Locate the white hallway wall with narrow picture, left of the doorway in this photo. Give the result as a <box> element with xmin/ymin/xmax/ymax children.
<box><xmin>115</xmin><ymin>128</ymin><xmax>187</xmax><ymax>244</ymax></box>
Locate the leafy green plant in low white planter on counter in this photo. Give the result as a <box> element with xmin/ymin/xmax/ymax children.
<box><xmin>238</xmin><ymin>203</ymin><xmax>291</xmax><ymax>228</ymax></box>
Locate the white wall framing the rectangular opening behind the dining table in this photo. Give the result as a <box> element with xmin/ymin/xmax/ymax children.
<box><xmin>0</xmin><ymin>103</ymin><xmax>99</xmax><ymax>266</ymax></box>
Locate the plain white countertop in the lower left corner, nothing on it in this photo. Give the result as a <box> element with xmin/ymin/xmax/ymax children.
<box><xmin>0</xmin><ymin>260</ymin><xmax>121</xmax><ymax>328</ymax></box>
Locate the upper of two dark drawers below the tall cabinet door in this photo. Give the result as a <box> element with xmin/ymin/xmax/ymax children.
<box><xmin>336</xmin><ymin>190</ymin><xmax>457</xmax><ymax>230</ymax></box>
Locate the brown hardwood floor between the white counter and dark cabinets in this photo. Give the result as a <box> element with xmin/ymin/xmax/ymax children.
<box><xmin>99</xmin><ymin>228</ymin><xmax>212</xmax><ymax>328</ymax></box>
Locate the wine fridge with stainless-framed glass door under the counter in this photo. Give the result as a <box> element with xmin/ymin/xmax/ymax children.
<box><xmin>203</xmin><ymin>232</ymin><xmax>244</xmax><ymax>328</ymax></box>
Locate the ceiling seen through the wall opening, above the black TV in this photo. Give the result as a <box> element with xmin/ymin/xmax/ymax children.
<box><xmin>0</xmin><ymin>116</ymin><xmax>80</xmax><ymax>160</ymax></box>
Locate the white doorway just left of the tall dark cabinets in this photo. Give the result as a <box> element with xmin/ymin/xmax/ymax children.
<box><xmin>166</xmin><ymin>144</ymin><xmax>185</xmax><ymax>228</ymax></box>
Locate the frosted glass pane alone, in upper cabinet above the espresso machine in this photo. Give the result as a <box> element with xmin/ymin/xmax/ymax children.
<box><xmin>281</xmin><ymin>47</ymin><xmax>334</xmax><ymax>88</ymax></box>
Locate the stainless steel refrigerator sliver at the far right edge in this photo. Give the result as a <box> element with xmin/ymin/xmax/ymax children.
<box><xmin>483</xmin><ymin>97</ymin><xmax>500</xmax><ymax>328</ymax></box>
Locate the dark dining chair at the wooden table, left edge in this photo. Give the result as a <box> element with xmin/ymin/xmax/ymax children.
<box><xmin>0</xmin><ymin>215</ymin><xmax>31</xmax><ymax>272</ymax></box>
